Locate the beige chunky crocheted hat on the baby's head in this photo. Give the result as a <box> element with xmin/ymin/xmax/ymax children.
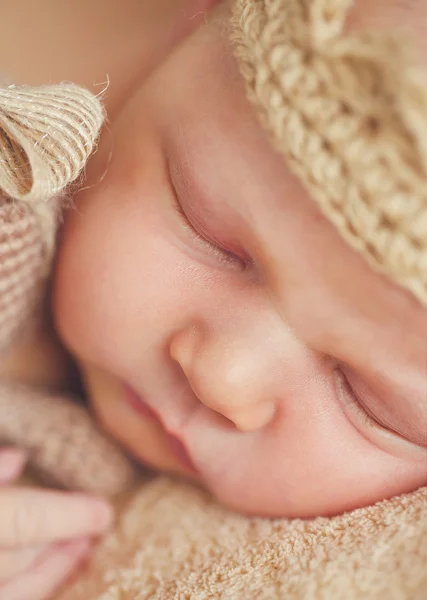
<box><xmin>232</xmin><ymin>0</ymin><xmax>427</xmax><ymax>304</ymax></box>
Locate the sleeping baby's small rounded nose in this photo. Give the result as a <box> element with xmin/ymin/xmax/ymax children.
<box><xmin>170</xmin><ymin>329</ymin><xmax>276</xmax><ymax>432</ymax></box>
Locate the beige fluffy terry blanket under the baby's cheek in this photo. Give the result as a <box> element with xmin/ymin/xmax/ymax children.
<box><xmin>58</xmin><ymin>477</ymin><xmax>427</xmax><ymax>600</ymax></box>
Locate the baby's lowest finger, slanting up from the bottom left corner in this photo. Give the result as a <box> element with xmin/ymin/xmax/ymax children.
<box><xmin>0</xmin><ymin>540</ymin><xmax>90</xmax><ymax>600</ymax></box>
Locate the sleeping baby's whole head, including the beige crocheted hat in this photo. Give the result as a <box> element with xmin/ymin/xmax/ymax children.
<box><xmin>0</xmin><ymin>0</ymin><xmax>427</xmax><ymax>598</ymax></box>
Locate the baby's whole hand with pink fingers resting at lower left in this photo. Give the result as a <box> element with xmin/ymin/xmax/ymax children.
<box><xmin>0</xmin><ymin>449</ymin><xmax>112</xmax><ymax>600</ymax></box>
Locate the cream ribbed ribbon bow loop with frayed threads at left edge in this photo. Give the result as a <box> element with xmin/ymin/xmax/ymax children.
<box><xmin>0</xmin><ymin>84</ymin><xmax>104</xmax><ymax>201</ymax></box>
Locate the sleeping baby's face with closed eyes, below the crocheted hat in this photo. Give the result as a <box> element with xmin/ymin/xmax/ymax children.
<box><xmin>56</xmin><ymin>0</ymin><xmax>427</xmax><ymax>517</ymax></box>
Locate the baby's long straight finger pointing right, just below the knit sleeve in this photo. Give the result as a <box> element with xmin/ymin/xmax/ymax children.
<box><xmin>0</xmin><ymin>487</ymin><xmax>112</xmax><ymax>548</ymax></box>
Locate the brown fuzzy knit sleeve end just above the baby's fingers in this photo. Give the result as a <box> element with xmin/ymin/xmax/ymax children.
<box><xmin>0</xmin><ymin>384</ymin><xmax>134</xmax><ymax>496</ymax></box>
